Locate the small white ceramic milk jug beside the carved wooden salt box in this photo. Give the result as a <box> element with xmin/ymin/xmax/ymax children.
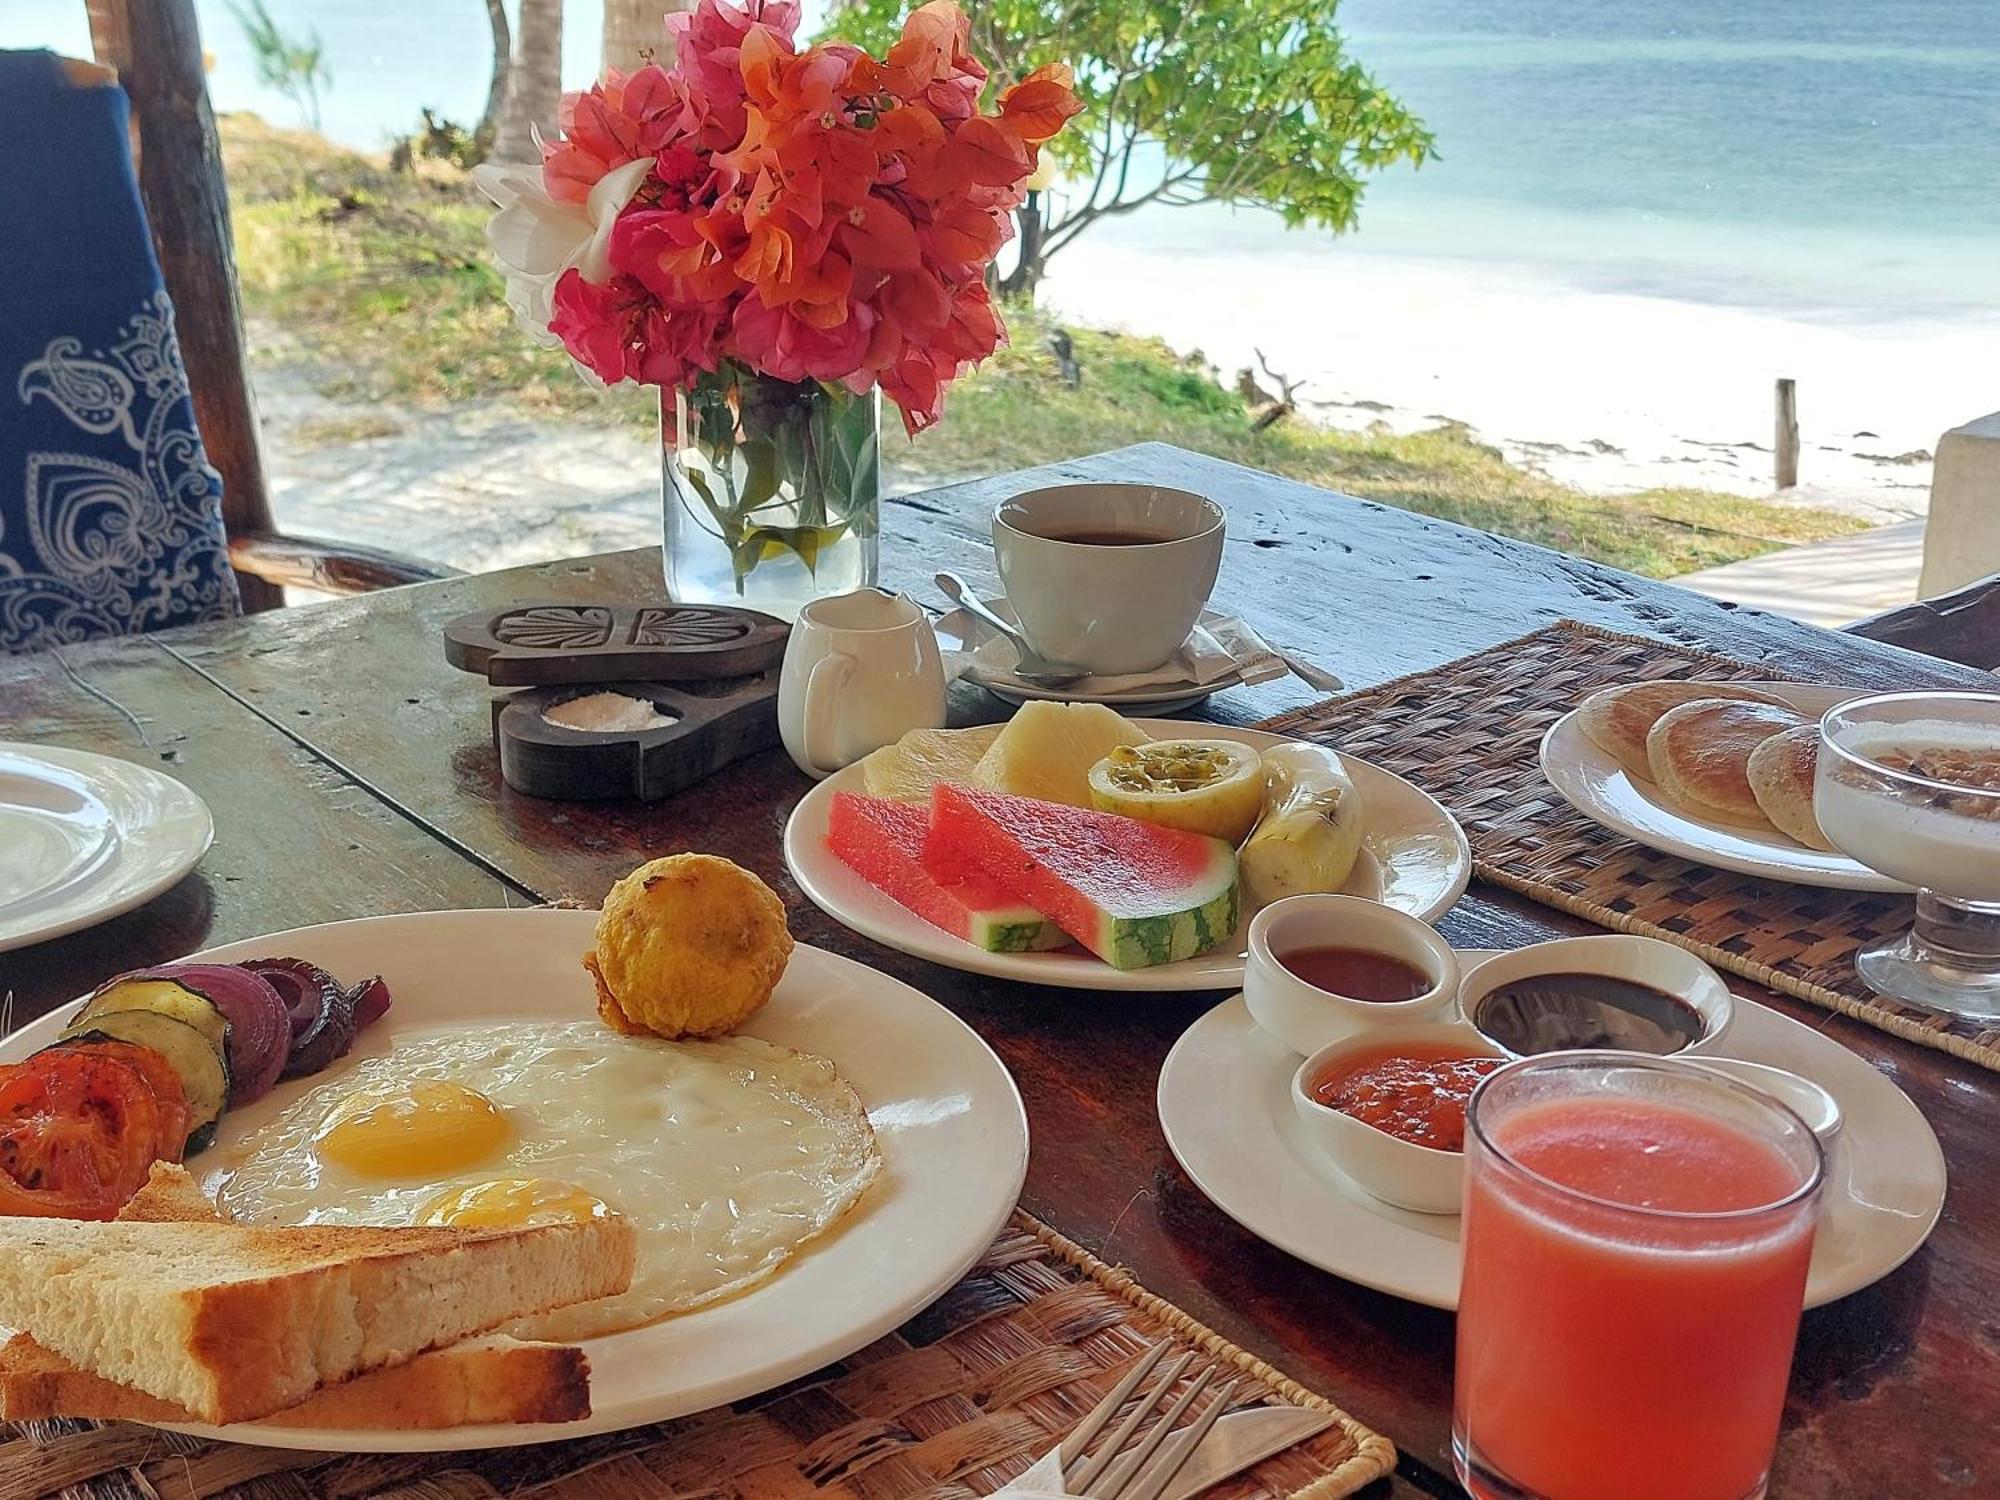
<box><xmin>778</xmin><ymin>588</ymin><xmax>944</xmax><ymax>778</ymax></box>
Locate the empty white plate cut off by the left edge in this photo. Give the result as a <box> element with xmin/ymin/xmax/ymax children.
<box><xmin>0</xmin><ymin>742</ymin><xmax>214</xmax><ymax>952</ymax></box>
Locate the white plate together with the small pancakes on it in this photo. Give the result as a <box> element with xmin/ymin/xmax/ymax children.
<box><xmin>1542</xmin><ymin>680</ymin><xmax>1910</xmax><ymax>890</ymax></box>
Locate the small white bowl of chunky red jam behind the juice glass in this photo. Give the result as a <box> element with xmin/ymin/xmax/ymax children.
<box><xmin>1292</xmin><ymin>1020</ymin><xmax>1508</xmax><ymax>1214</ymax></box>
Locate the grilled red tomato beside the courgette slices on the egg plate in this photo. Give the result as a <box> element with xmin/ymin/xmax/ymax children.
<box><xmin>0</xmin><ymin>1046</ymin><xmax>162</xmax><ymax>1218</ymax></box>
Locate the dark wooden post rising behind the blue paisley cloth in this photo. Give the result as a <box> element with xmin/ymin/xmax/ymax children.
<box><xmin>88</xmin><ymin>0</ymin><xmax>284</xmax><ymax>610</ymax></box>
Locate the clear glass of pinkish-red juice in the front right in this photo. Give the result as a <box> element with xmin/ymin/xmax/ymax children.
<box><xmin>1452</xmin><ymin>1052</ymin><xmax>1826</xmax><ymax>1500</ymax></box>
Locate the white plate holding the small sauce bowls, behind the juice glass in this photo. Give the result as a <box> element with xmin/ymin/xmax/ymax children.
<box><xmin>1160</xmin><ymin>952</ymin><xmax>1944</xmax><ymax>1308</ymax></box>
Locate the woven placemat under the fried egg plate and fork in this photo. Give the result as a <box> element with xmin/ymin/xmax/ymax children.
<box><xmin>0</xmin><ymin>1214</ymin><xmax>1396</xmax><ymax>1500</ymax></box>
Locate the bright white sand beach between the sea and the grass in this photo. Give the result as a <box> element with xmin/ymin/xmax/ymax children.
<box><xmin>1044</xmin><ymin>238</ymin><xmax>2000</xmax><ymax>522</ymax></box>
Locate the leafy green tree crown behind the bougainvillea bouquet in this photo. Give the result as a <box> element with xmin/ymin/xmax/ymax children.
<box><xmin>828</xmin><ymin>0</ymin><xmax>1432</xmax><ymax>290</ymax></box>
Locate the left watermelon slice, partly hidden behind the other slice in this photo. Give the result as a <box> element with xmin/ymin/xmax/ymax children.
<box><xmin>826</xmin><ymin>792</ymin><xmax>1068</xmax><ymax>954</ymax></box>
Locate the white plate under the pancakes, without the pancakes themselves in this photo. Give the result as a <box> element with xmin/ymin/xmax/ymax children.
<box><xmin>1542</xmin><ymin>682</ymin><xmax>1910</xmax><ymax>890</ymax></box>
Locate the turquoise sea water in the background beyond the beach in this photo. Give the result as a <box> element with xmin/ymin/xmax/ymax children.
<box><xmin>0</xmin><ymin>0</ymin><xmax>2000</xmax><ymax>320</ymax></box>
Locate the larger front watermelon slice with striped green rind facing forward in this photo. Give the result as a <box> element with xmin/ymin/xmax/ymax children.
<box><xmin>924</xmin><ymin>784</ymin><xmax>1238</xmax><ymax>968</ymax></box>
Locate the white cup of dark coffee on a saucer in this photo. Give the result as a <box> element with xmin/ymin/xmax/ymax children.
<box><xmin>994</xmin><ymin>484</ymin><xmax>1224</xmax><ymax>676</ymax></box>
